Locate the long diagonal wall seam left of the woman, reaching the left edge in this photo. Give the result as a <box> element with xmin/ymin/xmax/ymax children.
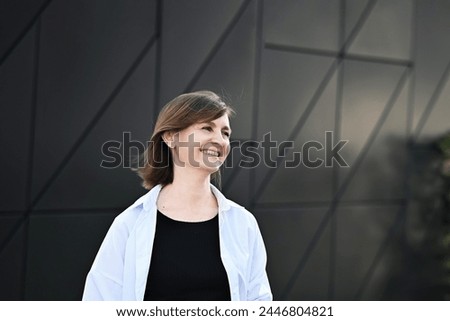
<box><xmin>0</xmin><ymin>35</ymin><xmax>156</xmax><ymax>254</ymax></box>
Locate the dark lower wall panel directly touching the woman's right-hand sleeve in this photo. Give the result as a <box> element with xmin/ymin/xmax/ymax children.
<box><xmin>255</xmin><ymin>208</ymin><xmax>330</xmax><ymax>300</ymax></box>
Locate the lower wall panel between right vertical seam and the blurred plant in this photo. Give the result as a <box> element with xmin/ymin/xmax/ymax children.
<box><xmin>335</xmin><ymin>206</ymin><xmax>401</xmax><ymax>300</ymax></box>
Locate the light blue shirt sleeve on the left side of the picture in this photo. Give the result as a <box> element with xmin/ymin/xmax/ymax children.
<box><xmin>82</xmin><ymin>218</ymin><xmax>128</xmax><ymax>301</ymax></box>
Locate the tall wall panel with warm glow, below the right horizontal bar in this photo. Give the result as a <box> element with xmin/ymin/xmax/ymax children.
<box><xmin>339</xmin><ymin>62</ymin><xmax>406</xmax><ymax>200</ymax></box>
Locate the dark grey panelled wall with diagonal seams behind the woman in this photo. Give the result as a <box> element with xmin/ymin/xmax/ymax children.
<box><xmin>0</xmin><ymin>0</ymin><xmax>450</xmax><ymax>300</ymax></box>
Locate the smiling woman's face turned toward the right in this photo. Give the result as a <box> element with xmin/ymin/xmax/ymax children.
<box><xmin>173</xmin><ymin>114</ymin><xmax>231</xmax><ymax>173</ymax></box>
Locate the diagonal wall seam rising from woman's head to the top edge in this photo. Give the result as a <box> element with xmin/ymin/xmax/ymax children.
<box><xmin>184</xmin><ymin>0</ymin><xmax>251</xmax><ymax>92</ymax></box>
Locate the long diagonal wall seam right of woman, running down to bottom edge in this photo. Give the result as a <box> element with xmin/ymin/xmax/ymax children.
<box><xmin>281</xmin><ymin>68</ymin><xmax>411</xmax><ymax>300</ymax></box>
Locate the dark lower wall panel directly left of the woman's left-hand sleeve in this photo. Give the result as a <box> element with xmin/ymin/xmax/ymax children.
<box><xmin>25</xmin><ymin>211</ymin><xmax>118</xmax><ymax>301</ymax></box>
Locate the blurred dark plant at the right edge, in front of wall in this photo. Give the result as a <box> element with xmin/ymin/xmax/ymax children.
<box><xmin>405</xmin><ymin>132</ymin><xmax>450</xmax><ymax>300</ymax></box>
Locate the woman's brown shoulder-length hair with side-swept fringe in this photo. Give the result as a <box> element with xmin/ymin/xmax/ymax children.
<box><xmin>135</xmin><ymin>91</ymin><xmax>234</xmax><ymax>189</ymax></box>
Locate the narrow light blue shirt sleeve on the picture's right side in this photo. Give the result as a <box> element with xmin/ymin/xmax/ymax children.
<box><xmin>247</xmin><ymin>215</ymin><xmax>273</xmax><ymax>301</ymax></box>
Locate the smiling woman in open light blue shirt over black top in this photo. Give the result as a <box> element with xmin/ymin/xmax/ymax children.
<box><xmin>83</xmin><ymin>91</ymin><xmax>272</xmax><ymax>301</ymax></box>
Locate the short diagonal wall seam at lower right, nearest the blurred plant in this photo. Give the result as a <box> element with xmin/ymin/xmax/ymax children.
<box><xmin>354</xmin><ymin>200</ymin><xmax>406</xmax><ymax>300</ymax></box>
